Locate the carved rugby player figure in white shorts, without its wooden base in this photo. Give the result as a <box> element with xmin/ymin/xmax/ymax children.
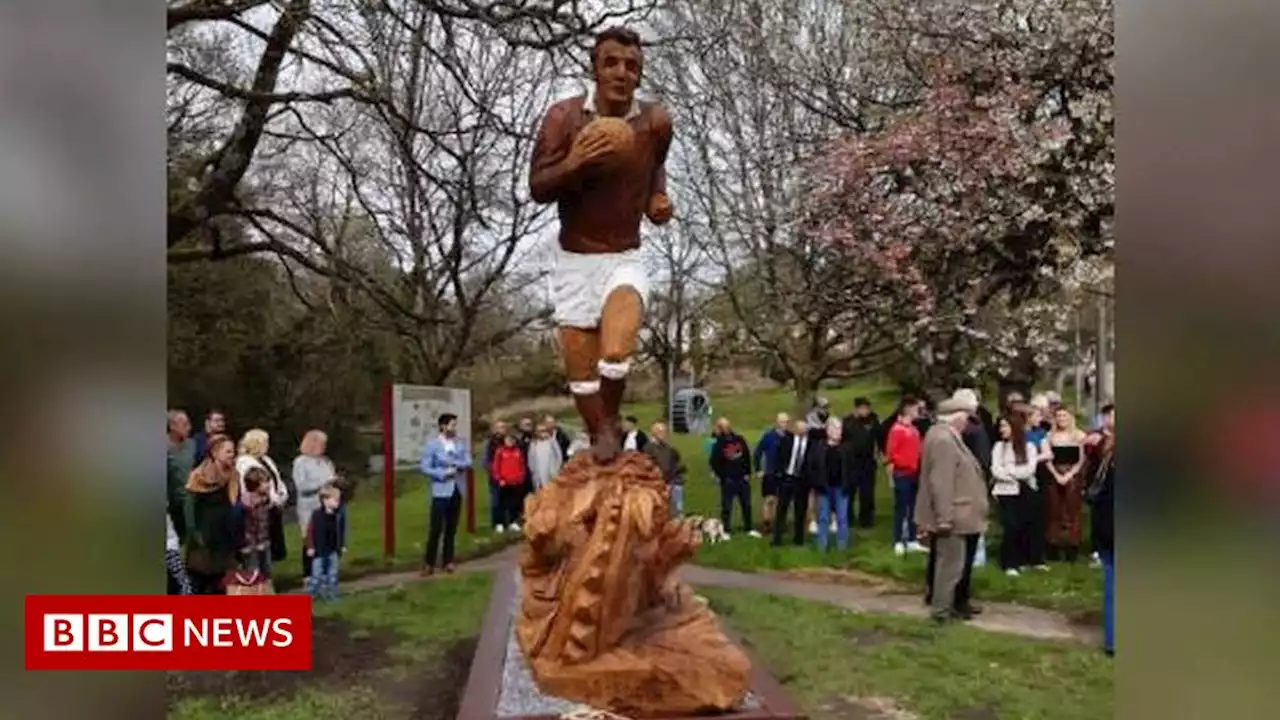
<box><xmin>529</xmin><ymin>28</ymin><xmax>672</xmax><ymax>462</ymax></box>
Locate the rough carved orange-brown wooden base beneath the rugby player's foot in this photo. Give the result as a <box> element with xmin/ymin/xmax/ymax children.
<box><xmin>516</xmin><ymin>452</ymin><xmax>751</xmax><ymax>717</ymax></box>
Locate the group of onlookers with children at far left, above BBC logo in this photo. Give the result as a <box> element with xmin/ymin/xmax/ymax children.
<box><xmin>165</xmin><ymin>410</ymin><xmax>346</xmax><ymax>600</ymax></box>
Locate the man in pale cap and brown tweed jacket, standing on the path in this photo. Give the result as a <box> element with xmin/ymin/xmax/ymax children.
<box><xmin>915</xmin><ymin>397</ymin><xmax>988</xmax><ymax>623</ymax></box>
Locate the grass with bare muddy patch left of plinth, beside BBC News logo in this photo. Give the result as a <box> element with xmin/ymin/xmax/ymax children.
<box><xmin>168</xmin><ymin>573</ymin><xmax>492</xmax><ymax>720</ymax></box>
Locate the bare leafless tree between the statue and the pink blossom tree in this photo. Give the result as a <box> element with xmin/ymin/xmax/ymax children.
<box><xmin>646</xmin><ymin>0</ymin><xmax>899</xmax><ymax>402</ymax></box>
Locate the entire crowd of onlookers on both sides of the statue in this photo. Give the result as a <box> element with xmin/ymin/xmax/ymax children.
<box><xmin>165</xmin><ymin>388</ymin><xmax>1115</xmax><ymax>652</ymax></box>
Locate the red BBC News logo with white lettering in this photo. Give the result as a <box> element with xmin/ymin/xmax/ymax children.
<box><xmin>26</xmin><ymin>594</ymin><xmax>311</xmax><ymax>670</ymax></box>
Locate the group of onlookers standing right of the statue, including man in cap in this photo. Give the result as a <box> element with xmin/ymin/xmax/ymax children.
<box><xmin>709</xmin><ymin>388</ymin><xmax>1115</xmax><ymax>652</ymax></box>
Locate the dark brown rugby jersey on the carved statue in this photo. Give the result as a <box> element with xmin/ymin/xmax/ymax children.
<box><xmin>529</xmin><ymin>95</ymin><xmax>671</xmax><ymax>255</ymax></box>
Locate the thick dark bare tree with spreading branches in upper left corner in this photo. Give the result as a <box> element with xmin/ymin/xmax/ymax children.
<box><xmin>168</xmin><ymin>0</ymin><xmax>648</xmax><ymax>252</ymax></box>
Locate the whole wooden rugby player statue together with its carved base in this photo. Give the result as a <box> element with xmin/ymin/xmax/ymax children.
<box><xmin>516</xmin><ymin>28</ymin><xmax>750</xmax><ymax>717</ymax></box>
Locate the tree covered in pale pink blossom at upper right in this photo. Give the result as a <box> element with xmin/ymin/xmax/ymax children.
<box><xmin>804</xmin><ymin>0</ymin><xmax>1115</xmax><ymax>389</ymax></box>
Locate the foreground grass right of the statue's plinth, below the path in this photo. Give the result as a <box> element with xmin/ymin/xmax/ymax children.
<box><xmin>700</xmin><ymin>588</ymin><xmax>1115</xmax><ymax>720</ymax></box>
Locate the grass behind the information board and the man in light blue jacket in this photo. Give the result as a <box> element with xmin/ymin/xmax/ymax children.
<box><xmin>273</xmin><ymin>471</ymin><xmax>515</xmax><ymax>589</ymax></box>
